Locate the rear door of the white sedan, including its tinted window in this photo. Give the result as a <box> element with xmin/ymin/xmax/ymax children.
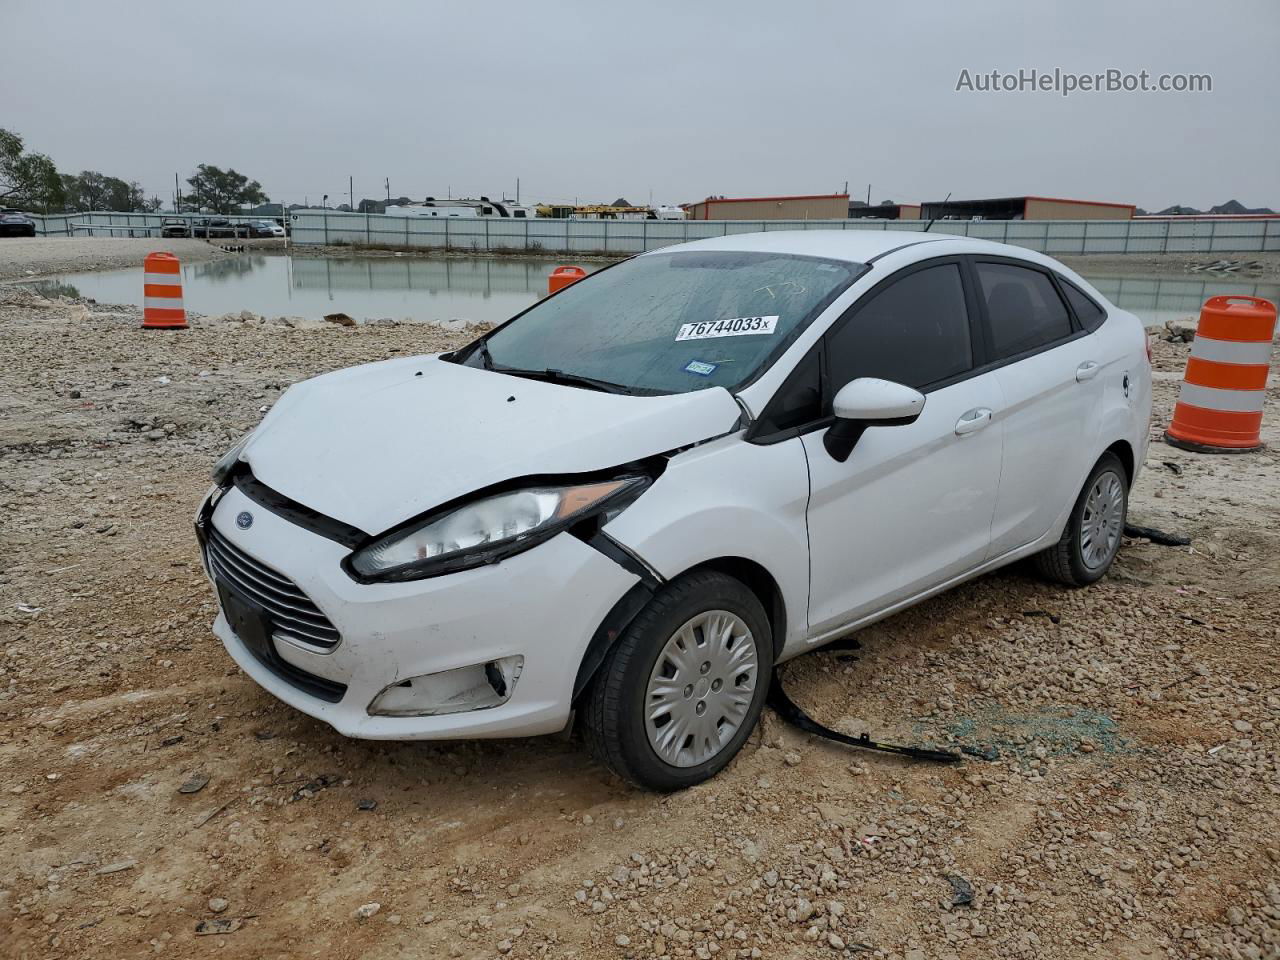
<box><xmin>972</xmin><ymin>257</ymin><xmax>1103</xmax><ymax>557</ymax></box>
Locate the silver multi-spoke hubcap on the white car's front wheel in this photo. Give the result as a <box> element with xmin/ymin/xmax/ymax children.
<box><xmin>645</xmin><ymin>611</ymin><xmax>758</xmax><ymax>767</ymax></box>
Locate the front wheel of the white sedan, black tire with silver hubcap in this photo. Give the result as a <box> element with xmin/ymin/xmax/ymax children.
<box><xmin>582</xmin><ymin>571</ymin><xmax>773</xmax><ymax>792</ymax></box>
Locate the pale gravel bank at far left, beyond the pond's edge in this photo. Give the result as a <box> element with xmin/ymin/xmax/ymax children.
<box><xmin>0</xmin><ymin>237</ymin><xmax>244</xmax><ymax>280</ymax></box>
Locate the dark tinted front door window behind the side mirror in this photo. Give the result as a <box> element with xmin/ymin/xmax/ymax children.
<box><xmin>827</xmin><ymin>264</ymin><xmax>973</xmax><ymax>390</ymax></box>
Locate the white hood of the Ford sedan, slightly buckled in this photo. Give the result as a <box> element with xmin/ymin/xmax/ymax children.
<box><xmin>241</xmin><ymin>356</ymin><xmax>740</xmax><ymax>534</ymax></box>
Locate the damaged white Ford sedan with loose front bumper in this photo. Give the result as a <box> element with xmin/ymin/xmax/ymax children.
<box><xmin>196</xmin><ymin>230</ymin><xmax>1151</xmax><ymax>790</ymax></box>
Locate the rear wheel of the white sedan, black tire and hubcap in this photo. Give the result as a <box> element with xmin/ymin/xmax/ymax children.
<box><xmin>1033</xmin><ymin>453</ymin><xmax>1129</xmax><ymax>586</ymax></box>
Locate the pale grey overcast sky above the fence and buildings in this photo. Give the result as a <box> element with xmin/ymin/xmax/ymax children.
<box><xmin>0</xmin><ymin>0</ymin><xmax>1280</xmax><ymax>209</ymax></box>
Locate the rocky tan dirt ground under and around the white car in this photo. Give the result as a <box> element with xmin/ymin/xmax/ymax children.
<box><xmin>0</xmin><ymin>280</ymin><xmax>1280</xmax><ymax>960</ymax></box>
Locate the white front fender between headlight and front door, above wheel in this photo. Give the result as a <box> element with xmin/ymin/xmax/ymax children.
<box><xmin>605</xmin><ymin>433</ymin><xmax>809</xmax><ymax>649</ymax></box>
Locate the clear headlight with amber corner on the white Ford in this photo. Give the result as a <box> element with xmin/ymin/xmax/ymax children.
<box><xmin>349</xmin><ymin>476</ymin><xmax>649</xmax><ymax>580</ymax></box>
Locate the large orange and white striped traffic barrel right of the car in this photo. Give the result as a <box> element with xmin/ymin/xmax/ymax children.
<box><xmin>1165</xmin><ymin>297</ymin><xmax>1276</xmax><ymax>453</ymax></box>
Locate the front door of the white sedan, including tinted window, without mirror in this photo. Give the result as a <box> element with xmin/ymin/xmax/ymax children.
<box><xmin>797</xmin><ymin>257</ymin><xmax>1004</xmax><ymax>636</ymax></box>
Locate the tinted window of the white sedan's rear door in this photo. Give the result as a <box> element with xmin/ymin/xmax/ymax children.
<box><xmin>974</xmin><ymin>261</ymin><xmax>1071</xmax><ymax>360</ymax></box>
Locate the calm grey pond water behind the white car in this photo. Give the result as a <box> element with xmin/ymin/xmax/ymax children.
<box><xmin>20</xmin><ymin>253</ymin><xmax>1280</xmax><ymax>326</ymax></box>
